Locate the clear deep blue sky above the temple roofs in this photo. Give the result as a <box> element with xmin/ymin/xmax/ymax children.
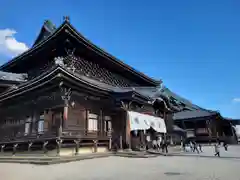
<box><xmin>0</xmin><ymin>0</ymin><xmax>240</xmax><ymax>118</ymax></box>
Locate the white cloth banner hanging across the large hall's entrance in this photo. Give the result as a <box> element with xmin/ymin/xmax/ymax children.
<box><xmin>128</xmin><ymin>111</ymin><xmax>167</xmax><ymax>133</ymax></box>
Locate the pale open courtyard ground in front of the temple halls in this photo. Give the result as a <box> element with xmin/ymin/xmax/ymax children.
<box><xmin>0</xmin><ymin>146</ymin><xmax>240</xmax><ymax>180</ymax></box>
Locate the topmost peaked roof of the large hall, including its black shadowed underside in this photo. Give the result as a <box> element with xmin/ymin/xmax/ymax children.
<box><xmin>0</xmin><ymin>20</ymin><xmax>161</xmax><ymax>86</ymax></box>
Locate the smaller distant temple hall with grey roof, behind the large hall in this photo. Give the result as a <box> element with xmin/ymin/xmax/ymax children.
<box><xmin>161</xmin><ymin>87</ymin><xmax>237</xmax><ymax>143</ymax></box>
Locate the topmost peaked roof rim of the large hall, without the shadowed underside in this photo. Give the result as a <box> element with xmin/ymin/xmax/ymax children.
<box><xmin>0</xmin><ymin>20</ymin><xmax>161</xmax><ymax>86</ymax></box>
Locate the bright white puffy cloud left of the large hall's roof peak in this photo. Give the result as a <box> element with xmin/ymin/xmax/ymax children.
<box><xmin>0</xmin><ymin>29</ymin><xmax>28</xmax><ymax>57</ymax></box>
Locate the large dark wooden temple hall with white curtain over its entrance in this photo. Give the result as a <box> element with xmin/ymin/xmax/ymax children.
<box><xmin>0</xmin><ymin>17</ymin><xmax>173</xmax><ymax>155</ymax></box>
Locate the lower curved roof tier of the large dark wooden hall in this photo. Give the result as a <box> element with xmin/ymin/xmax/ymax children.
<box><xmin>0</xmin><ymin>66</ymin><xmax>157</xmax><ymax>101</ymax></box>
